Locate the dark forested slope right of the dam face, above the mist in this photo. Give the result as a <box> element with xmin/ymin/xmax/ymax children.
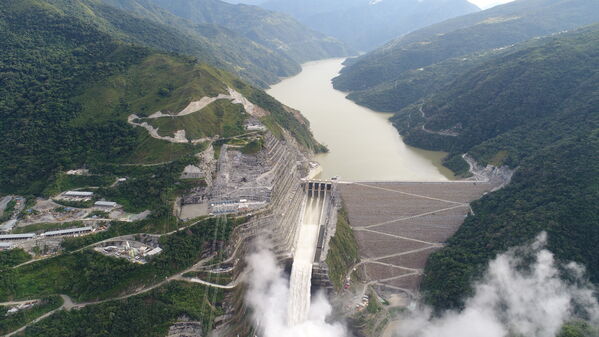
<box><xmin>422</xmin><ymin>133</ymin><xmax>599</xmax><ymax>309</ymax></box>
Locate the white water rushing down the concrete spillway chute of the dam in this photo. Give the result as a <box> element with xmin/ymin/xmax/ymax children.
<box><xmin>287</xmin><ymin>190</ymin><xmax>327</xmax><ymax>326</ymax></box>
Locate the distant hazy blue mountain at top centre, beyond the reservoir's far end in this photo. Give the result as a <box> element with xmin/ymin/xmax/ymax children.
<box><xmin>260</xmin><ymin>0</ymin><xmax>479</xmax><ymax>51</ymax></box>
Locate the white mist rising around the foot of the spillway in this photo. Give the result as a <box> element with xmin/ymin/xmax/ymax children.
<box><xmin>246</xmin><ymin>241</ymin><xmax>348</xmax><ymax>337</ymax></box>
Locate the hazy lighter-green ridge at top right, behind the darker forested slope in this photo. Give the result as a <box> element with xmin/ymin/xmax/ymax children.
<box><xmin>334</xmin><ymin>0</ymin><xmax>599</xmax><ymax>107</ymax></box>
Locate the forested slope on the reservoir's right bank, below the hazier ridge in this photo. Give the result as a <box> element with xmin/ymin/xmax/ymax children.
<box><xmin>393</xmin><ymin>25</ymin><xmax>599</xmax><ymax>167</ymax></box>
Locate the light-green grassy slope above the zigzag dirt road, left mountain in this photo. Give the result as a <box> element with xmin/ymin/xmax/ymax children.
<box><xmin>73</xmin><ymin>54</ymin><xmax>228</xmax><ymax>125</ymax></box>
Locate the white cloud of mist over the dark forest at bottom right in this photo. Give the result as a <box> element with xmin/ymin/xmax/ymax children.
<box><xmin>397</xmin><ymin>234</ymin><xmax>599</xmax><ymax>337</ymax></box>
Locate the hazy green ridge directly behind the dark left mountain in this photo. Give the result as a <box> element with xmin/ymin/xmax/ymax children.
<box><xmin>37</xmin><ymin>0</ymin><xmax>299</xmax><ymax>86</ymax></box>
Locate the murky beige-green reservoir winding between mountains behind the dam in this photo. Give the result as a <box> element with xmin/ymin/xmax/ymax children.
<box><xmin>268</xmin><ymin>59</ymin><xmax>453</xmax><ymax>181</ymax></box>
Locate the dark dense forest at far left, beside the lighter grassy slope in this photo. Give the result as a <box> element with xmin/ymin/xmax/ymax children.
<box><xmin>0</xmin><ymin>0</ymin><xmax>149</xmax><ymax>193</ymax></box>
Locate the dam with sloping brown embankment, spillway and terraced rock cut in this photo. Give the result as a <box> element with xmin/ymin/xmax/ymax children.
<box><xmin>200</xmin><ymin>130</ymin><xmax>502</xmax><ymax>337</ymax></box>
